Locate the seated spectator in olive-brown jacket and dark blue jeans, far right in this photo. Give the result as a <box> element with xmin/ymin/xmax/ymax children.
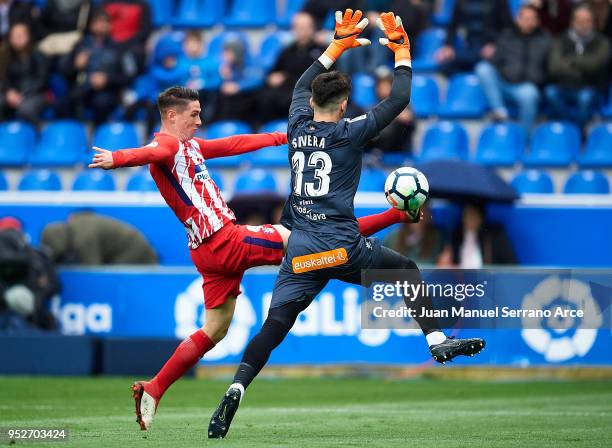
<box><xmin>545</xmin><ymin>5</ymin><xmax>610</xmax><ymax>131</ymax></box>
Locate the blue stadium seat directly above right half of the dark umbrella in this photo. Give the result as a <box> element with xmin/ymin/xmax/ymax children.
<box><xmin>475</xmin><ymin>122</ymin><xmax>525</xmax><ymax>166</ymax></box>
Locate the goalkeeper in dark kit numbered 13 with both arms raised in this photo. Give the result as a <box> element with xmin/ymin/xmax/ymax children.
<box><xmin>208</xmin><ymin>9</ymin><xmax>484</xmax><ymax>438</ymax></box>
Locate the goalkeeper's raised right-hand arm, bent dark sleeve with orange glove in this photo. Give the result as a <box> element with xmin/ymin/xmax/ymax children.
<box><xmin>372</xmin><ymin>12</ymin><xmax>412</xmax><ymax>131</ymax></box>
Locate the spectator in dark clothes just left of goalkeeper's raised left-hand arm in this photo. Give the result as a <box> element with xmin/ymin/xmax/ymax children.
<box><xmin>258</xmin><ymin>12</ymin><xmax>324</xmax><ymax>123</ymax></box>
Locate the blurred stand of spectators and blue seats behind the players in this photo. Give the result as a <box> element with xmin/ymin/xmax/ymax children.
<box><xmin>0</xmin><ymin>0</ymin><xmax>612</xmax><ymax>186</ymax></box>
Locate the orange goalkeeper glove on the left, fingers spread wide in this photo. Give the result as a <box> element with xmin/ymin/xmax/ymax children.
<box><xmin>321</xmin><ymin>9</ymin><xmax>371</xmax><ymax>68</ymax></box>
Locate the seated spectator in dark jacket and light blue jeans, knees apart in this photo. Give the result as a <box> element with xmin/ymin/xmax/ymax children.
<box><xmin>476</xmin><ymin>5</ymin><xmax>550</xmax><ymax>135</ymax></box>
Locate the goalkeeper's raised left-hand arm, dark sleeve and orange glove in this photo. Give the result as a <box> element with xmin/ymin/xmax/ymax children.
<box><xmin>289</xmin><ymin>9</ymin><xmax>370</xmax><ymax>116</ymax></box>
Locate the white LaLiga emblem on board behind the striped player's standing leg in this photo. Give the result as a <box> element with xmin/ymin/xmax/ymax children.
<box><xmin>174</xmin><ymin>278</ymin><xmax>257</xmax><ymax>361</ymax></box>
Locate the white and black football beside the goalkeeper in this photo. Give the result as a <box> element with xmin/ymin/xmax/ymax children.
<box><xmin>385</xmin><ymin>167</ymin><xmax>429</xmax><ymax>215</ymax></box>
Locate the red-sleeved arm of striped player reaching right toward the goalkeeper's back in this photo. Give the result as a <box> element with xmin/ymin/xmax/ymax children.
<box><xmin>195</xmin><ymin>132</ymin><xmax>287</xmax><ymax>159</ymax></box>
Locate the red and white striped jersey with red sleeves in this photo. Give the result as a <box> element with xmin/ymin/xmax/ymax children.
<box><xmin>113</xmin><ymin>132</ymin><xmax>287</xmax><ymax>249</ymax></box>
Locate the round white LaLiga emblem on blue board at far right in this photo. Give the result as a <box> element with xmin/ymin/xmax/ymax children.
<box><xmin>521</xmin><ymin>276</ymin><xmax>602</xmax><ymax>362</ymax></box>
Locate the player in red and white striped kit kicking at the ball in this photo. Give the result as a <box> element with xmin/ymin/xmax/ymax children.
<box><xmin>89</xmin><ymin>87</ymin><xmax>410</xmax><ymax>430</ymax></box>
